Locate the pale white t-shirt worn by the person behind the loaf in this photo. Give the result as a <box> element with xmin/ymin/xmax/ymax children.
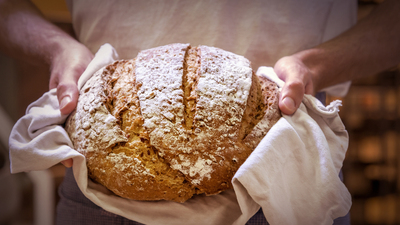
<box><xmin>67</xmin><ymin>0</ymin><xmax>357</xmax><ymax>69</ymax></box>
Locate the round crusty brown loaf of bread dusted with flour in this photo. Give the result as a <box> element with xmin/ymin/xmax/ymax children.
<box><xmin>65</xmin><ymin>44</ymin><xmax>281</xmax><ymax>202</ymax></box>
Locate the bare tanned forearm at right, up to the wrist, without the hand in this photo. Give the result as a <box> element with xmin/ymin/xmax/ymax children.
<box><xmin>293</xmin><ymin>0</ymin><xmax>400</xmax><ymax>91</ymax></box>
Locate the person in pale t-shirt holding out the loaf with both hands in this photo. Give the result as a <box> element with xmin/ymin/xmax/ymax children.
<box><xmin>0</xmin><ymin>0</ymin><xmax>400</xmax><ymax>224</ymax></box>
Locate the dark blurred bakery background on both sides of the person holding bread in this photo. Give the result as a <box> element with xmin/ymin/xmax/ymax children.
<box><xmin>0</xmin><ymin>0</ymin><xmax>400</xmax><ymax>225</ymax></box>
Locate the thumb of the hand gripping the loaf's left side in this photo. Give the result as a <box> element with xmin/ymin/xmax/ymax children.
<box><xmin>57</xmin><ymin>82</ymin><xmax>79</xmax><ymax>115</ymax></box>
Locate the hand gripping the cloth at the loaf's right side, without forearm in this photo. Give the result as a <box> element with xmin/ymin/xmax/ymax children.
<box><xmin>274</xmin><ymin>56</ymin><xmax>315</xmax><ymax>115</ymax></box>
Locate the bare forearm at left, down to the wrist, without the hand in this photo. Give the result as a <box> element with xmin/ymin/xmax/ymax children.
<box><xmin>0</xmin><ymin>0</ymin><xmax>79</xmax><ymax>66</ymax></box>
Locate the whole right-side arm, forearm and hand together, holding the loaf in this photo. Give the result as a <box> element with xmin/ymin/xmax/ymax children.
<box><xmin>274</xmin><ymin>1</ymin><xmax>400</xmax><ymax>115</ymax></box>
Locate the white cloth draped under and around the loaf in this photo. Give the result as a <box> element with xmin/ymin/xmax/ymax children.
<box><xmin>9</xmin><ymin>44</ymin><xmax>351</xmax><ymax>225</ymax></box>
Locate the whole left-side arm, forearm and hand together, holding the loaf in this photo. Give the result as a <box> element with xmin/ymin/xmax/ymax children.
<box><xmin>0</xmin><ymin>0</ymin><xmax>93</xmax><ymax>119</ymax></box>
